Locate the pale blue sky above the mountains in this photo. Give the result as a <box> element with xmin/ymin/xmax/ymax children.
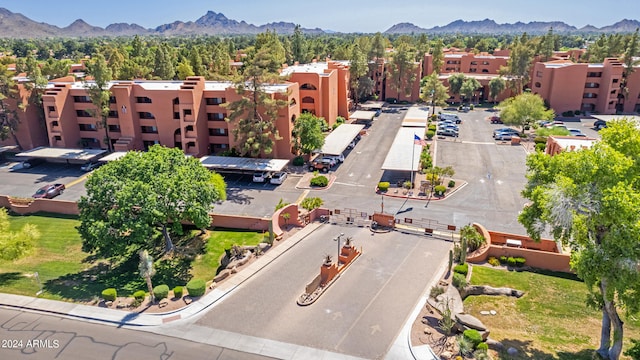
<box><xmin>0</xmin><ymin>0</ymin><xmax>640</xmax><ymax>32</ymax></box>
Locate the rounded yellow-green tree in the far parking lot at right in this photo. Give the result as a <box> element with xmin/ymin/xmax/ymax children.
<box><xmin>498</xmin><ymin>93</ymin><xmax>555</xmax><ymax>133</ymax></box>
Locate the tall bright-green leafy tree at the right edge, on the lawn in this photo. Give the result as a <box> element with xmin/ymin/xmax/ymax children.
<box><xmin>518</xmin><ymin>120</ymin><xmax>640</xmax><ymax>360</ymax></box>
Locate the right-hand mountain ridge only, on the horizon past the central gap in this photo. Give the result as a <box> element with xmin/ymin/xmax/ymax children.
<box><xmin>385</xmin><ymin>19</ymin><xmax>640</xmax><ymax>35</ymax></box>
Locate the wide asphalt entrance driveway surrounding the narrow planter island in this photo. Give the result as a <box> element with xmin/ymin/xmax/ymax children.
<box><xmin>197</xmin><ymin>225</ymin><xmax>452</xmax><ymax>359</ymax></box>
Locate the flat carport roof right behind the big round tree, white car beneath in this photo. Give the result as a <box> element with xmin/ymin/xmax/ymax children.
<box><xmin>200</xmin><ymin>156</ymin><xmax>289</xmax><ymax>174</ymax></box>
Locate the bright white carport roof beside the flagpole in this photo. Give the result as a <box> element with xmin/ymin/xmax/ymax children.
<box><xmin>382</xmin><ymin>127</ymin><xmax>425</xmax><ymax>171</ymax></box>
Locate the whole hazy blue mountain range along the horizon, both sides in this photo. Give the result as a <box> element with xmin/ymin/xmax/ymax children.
<box><xmin>0</xmin><ymin>8</ymin><xmax>640</xmax><ymax>38</ymax></box>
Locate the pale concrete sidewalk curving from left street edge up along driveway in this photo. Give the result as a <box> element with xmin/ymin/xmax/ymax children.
<box><xmin>0</xmin><ymin>223</ymin><xmax>321</xmax><ymax>327</ymax></box>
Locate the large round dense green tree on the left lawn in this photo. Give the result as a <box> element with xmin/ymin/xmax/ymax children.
<box><xmin>78</xmin><ymin>145</ymin><xmax>226</xmax><ymax>260</ymax></box>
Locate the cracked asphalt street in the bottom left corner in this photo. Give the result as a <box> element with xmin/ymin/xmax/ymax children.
<box><xmin>0</xmin><ymin>309</ymin><xmax>270</xmax><ymax>360</ymax></box>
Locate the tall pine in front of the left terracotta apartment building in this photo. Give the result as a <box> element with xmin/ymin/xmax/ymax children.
<box><xmin>225</xmin><ymin>50</ymin><xmax>286</xmax><ymax>157</ymax></box>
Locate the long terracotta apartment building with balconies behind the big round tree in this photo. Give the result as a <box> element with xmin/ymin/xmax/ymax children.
<box><xmin>43</xmin><ymin>77</ymin><xmax>300</xmax><ymax>158</ymax></box>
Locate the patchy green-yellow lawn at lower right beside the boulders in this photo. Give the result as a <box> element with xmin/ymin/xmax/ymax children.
<box><xmin>464</xmin><ymin>266</ymin><xmax>640</xmax><ymax>360</ymax></box>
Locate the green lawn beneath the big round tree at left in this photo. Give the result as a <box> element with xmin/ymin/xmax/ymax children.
<box><xmin>0</xmin><ymin>214</ymin><xmax>264</xmax><ymax>302</ymax></box>
